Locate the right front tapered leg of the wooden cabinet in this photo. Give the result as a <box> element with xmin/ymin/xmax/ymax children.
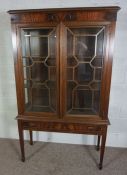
<box><xmin>99</xmin><ymin>127</ymin><xmax>107</xmax><ymax>169</ymax></box>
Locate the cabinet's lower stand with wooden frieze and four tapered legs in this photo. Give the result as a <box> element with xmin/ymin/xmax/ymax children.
<box><xmin>18</xmin><ymin>119</ymin><xmax>107</xmax><ymax>169</ymax></box>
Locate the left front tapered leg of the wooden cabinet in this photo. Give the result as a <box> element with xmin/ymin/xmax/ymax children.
<box><xmin>18</xmin><ymin>120</ymin><xmax>25</xmax><ymax>162</ymax></box>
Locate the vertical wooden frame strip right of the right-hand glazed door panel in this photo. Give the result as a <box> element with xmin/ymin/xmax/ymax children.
<box><xmin>101</xmin><ymin>22</ymin><xmax>116</xmax><ymax>119</ymax></box>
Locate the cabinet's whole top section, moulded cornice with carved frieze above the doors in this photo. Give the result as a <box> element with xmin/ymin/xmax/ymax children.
<box><xmin>8</xmin><ymin>6</ymin><xmax>120</xmax><ymax>24</ymax></box>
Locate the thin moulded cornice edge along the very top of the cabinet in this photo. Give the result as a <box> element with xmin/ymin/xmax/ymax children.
<box><xmin>8</xmin><ymin>6</ymin><xmax>120</xmax><ymax>14</ymax></box>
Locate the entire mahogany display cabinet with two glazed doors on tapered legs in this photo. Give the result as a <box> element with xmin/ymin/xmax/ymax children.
<box><xmin>8</xmin><ymin>7</ymin><xmax>120</xmax><ymax>169</ymax></box>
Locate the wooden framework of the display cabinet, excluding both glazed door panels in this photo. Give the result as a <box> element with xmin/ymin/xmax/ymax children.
<box><xmin>8</xmin><ymin>6</ymin><xmax>120</xmax><ymax>169</ymax></box>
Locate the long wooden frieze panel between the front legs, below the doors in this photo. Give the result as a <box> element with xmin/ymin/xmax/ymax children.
<box><xmin>23</xmin><ymin>121</ymin><xmax>103</xmax><ymax>135</ymax></box>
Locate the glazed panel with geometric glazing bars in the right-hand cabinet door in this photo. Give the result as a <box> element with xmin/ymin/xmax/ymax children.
<box><xmin>66</xmin><ymin>27</ymin><xmax>104</xmax><ymax>115</ymax></box>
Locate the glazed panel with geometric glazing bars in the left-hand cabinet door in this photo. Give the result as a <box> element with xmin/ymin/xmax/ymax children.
<box><xmin>21</xmin><ymin>28</ymin><xmax>57</xmax><ymax>112</ymax></box>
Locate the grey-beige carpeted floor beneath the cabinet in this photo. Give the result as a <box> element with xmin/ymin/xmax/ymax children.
<box><xmin>0</xmin><ymin>139</ymin><xmax>127</xmax><ymax>175</ymax></box>
